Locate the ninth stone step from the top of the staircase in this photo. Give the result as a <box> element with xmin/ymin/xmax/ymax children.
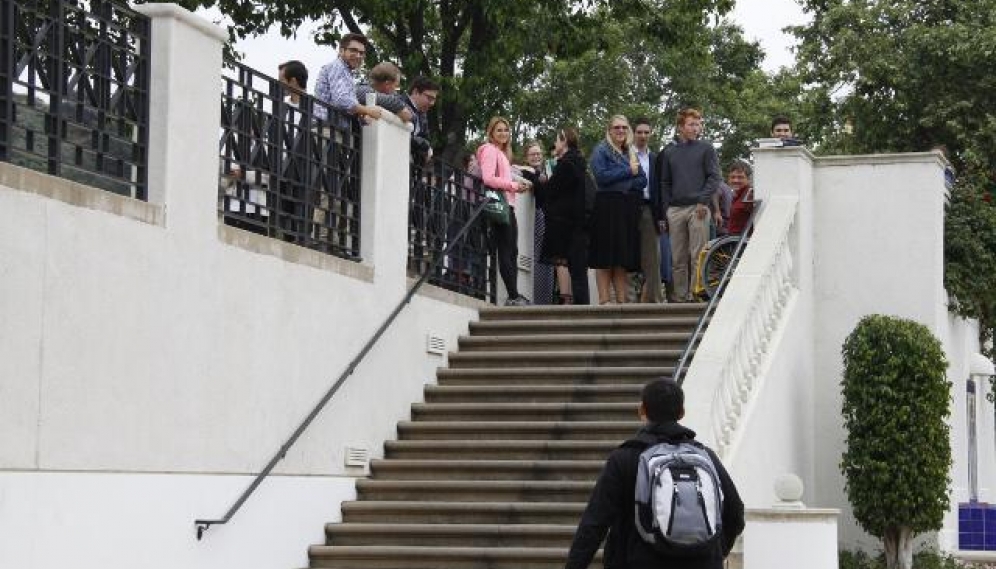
<box><xmin>384</xmin><ymin>440</ymin><xmax>619</xmax><ymax>460</ymax></box>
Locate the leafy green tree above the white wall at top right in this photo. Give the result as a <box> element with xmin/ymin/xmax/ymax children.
<box><xmin>793</xmin><ymin>0</ymin><xmax>996</xmax><ymax>170</ymax></box>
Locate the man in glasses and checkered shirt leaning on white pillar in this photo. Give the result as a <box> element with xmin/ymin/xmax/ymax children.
<box><xmin>315</xmin><ymin>34</ymin><xmax>381</xmax><ymax>126</ymax></box>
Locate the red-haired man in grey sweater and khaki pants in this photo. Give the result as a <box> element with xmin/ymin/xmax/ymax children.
<box><xmin>658</xmin><ymin>109</ymin><xmax>722</xmax><ymax>302</ymax></box>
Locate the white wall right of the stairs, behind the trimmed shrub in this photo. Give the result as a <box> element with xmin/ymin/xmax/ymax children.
<box><xmin>716</xmin><ymin>148</ymin><xmax>996</xmax><ymax>548</ymax></box>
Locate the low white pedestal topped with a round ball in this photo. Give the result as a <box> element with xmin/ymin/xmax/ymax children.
<box><xmin>743</xmin><ymin>474</ymin><xmax>840</xmax><ymax>569</ymax></box>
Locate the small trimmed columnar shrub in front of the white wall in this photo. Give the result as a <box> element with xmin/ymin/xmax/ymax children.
<box><xmin>841</xmin><ymin>315</ymin><xmax>951</xmax><ymax>569</ymax></box>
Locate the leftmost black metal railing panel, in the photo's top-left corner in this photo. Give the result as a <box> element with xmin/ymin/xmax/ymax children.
<box><xmin>0</xmin><ymin>0</ymin><xmax>151</xmax><ymax>200</ymax></box>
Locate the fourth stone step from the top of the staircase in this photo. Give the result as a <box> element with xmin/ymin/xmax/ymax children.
<box><xmin>449</xmin><ymin>349</ymin><xmax>681</xmax><ymax>370</ymax></box>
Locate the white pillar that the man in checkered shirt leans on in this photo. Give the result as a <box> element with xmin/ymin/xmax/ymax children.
<box><xmin>360</xmin><ymin>102</ymin><xmax>411</xmax><ymax>303</ymax></box>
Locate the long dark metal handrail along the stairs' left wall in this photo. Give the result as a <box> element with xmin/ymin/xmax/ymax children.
<box><xmin>194</xmin><ymin>193</ymin><xmax>489</xmax><ymax>541</ymax></box>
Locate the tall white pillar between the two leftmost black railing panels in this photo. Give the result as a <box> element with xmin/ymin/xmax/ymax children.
<box><xmin>135</xmin><ymin>4</ymin><xmax>227</xmax><ymax>240</ymax></box>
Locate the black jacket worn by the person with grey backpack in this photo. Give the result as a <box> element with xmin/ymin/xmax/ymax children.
<box><xmin>566</xmin><ymin>422</ymin><xmax>744</xmax><ymax>569</ymax></box>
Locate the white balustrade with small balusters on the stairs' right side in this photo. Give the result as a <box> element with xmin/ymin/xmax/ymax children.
<box><xmin>711</xmin><ymin>200</ymin><xmax>797</xmax><ymax>454</ymax></box>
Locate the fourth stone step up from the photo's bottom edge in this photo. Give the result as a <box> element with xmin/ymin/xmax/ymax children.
<box><xmin>356</xmin><ymin>478</ymin><xmax>595</xmax><ymax>502</ymax></box>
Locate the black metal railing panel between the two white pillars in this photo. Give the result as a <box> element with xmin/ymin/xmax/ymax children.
<box><xmin>218</xmin><ymin>62</ymin><xmax>362</xmax><ymax>260</ymax></box>
